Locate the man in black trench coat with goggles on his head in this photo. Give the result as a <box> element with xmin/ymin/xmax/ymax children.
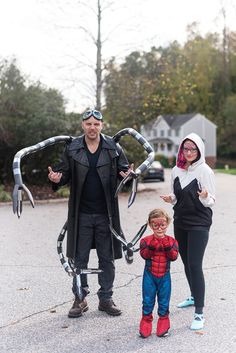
<box><xmin>48</xmin><ymin>110</ymin><xmax>130</xmax><ymax>318</ymax></box>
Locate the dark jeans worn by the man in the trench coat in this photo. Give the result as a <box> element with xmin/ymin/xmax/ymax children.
<box><xmin>72</xmin><ymin>213</ymin><xmax>115</xmax><ymax>300</ymax></box>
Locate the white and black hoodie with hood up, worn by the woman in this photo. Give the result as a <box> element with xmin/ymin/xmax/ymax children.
<box><xmin>171</xmin><ymin>133</ymin><xmax>215</xmax><ymax>230</ymax></box>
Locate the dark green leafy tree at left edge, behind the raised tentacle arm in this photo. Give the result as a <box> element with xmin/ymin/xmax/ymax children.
<box><xmin>0</xmin><ymin>60</ymin><xmax>68</xmax><ymax>182</ymax></box>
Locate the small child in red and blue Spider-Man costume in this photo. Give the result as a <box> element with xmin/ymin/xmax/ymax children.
<box><xmin>139</xmin><ymin>208</ymin><xmax>178</xmax><ymax>338</ymax></box>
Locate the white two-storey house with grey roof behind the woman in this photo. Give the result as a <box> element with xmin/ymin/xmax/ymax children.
<box><xmin>140</xmin><ymin>113</ymin><xmax>217</xmax><ymax>168</ymax></box>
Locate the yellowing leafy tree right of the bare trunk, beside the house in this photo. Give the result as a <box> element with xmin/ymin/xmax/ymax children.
<box><xmin>105</xmin><ymin>42</ymin><xmax>195</xmax><ymax>129</ymax></box>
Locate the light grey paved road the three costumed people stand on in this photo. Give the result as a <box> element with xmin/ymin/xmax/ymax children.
<box><xmin>0</xmin><ymin>171</ymin><xmax>236</xmax><ymax>353</ymax></box>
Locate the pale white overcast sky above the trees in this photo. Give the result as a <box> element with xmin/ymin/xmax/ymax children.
<box><xmin>0</xmin><ymin>0</ymin><xmax>236</xmax><ymax>112</ymax></box>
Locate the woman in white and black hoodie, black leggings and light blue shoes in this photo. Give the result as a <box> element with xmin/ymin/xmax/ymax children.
<box><xmin>161</xmin><ymin>133</ymin><xmax>215</xmax><ymax>330</ymax></box>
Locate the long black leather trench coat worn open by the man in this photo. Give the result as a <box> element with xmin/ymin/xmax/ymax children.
<box><xmin>54</xmin><ymin>135</ymin><xmax>129</xmax><ymax>260</ymax></box>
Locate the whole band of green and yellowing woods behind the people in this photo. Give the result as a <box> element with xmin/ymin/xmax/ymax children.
<box><xmin>0</xmin><ymin>24</ymin><xmax>236</xmax><ymax>184</ymax></box>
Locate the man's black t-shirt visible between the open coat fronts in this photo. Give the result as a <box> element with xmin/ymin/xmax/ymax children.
<box><xmin>80</xmin><ymin>136</ymin><xmax>107</xmax><ymax>213</ymax></box>
